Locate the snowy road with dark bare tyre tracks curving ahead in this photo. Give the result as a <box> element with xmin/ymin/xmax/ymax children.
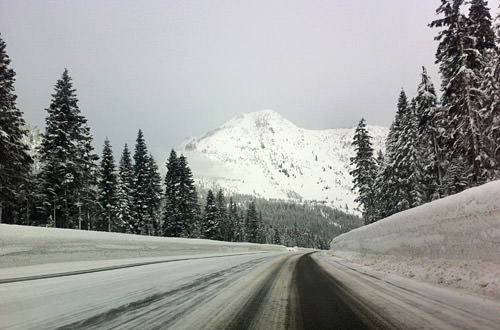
<box><xmin>0</xmin><ymin>252</ymin><xmax>500</xmax><ymax>329</ymax></box>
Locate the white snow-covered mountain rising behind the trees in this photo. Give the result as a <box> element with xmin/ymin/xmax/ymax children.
<box><xmin>179</xmin><ymin>110</ymin><xmax>388</xmax><ymax>213</ymax></box>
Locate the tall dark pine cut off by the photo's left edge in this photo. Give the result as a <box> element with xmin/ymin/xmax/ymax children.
<box><xmin>0</xmin><ymin>35</ymin><xmax>32</xmax><ymax>223</ymax></box>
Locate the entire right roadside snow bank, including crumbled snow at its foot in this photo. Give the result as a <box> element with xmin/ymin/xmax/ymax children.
<box><xmin>328</xmin><ymin>181</ymin><xmax>500</xmax><ymax>300</ymax></box>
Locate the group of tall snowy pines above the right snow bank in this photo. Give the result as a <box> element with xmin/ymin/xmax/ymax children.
<box><xmin>351</xmin><ymin>0</ymin><xmax>500</xmax><ymax>224</ymax></box>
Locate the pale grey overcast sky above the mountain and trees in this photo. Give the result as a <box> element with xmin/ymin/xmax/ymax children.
<box><xmin>0</xmin><ymin>0</ymin><xmax>499</xmax><ymax>161</ymax></box>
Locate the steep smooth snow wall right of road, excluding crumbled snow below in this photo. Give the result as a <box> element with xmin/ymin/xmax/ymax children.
<box><xmin>330</xmin><ymin>181</ymin><xmax>500</xmax><ymax>264</ymax></box>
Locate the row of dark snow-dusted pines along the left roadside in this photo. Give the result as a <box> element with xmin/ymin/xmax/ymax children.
<box><xmin>0</xmin><ymin>34</ymin><xmax>265</xmax><ymax>243</ymax></box>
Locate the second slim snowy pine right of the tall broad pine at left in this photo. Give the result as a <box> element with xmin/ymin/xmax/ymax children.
<box><xmin>116</xmin><ymin>144</ymin><xmax>135</xmax><ymax>233</ymax></box>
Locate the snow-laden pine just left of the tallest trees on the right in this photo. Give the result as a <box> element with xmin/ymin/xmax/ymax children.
<box><xmin>415</xmin><ymin>67</ymin><xmax>447</xmax><ymax>202</ymax></box>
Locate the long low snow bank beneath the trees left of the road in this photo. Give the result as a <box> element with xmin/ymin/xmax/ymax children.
<box><xmin>0</xmin><ymin>224</ymin><xmax>285</xmax><ymax>268</ymax></box>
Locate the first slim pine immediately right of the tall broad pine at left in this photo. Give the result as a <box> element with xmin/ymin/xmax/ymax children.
<box><xmin>95</xmin><ymin>138</ymin><xmax>119</xmax><ymax>231</ymax></box>
